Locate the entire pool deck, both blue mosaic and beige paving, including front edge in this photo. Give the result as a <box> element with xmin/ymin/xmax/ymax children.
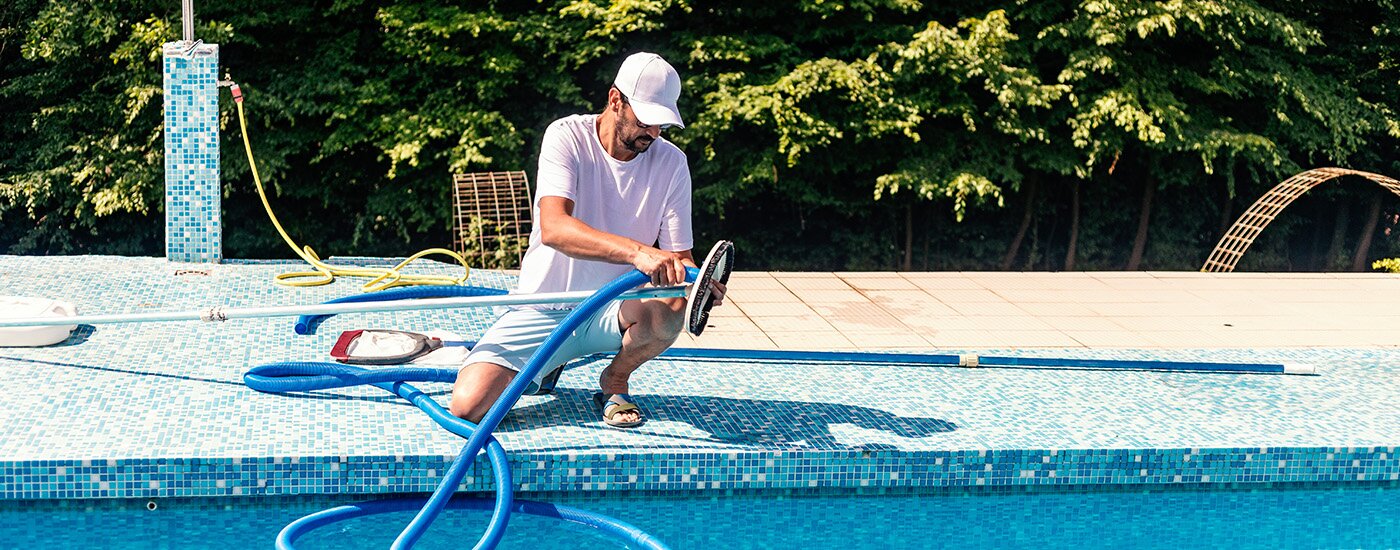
<box><xmin>0</xmin><ymin>256</ymin><xmax>1400</xmax><ymax>500</ymax></box>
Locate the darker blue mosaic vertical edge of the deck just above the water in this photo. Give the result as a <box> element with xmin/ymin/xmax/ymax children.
<box><xmin>0</xmin><ymin>446</ymin><xmax>1400</xmax><ymax>500</ymax></box>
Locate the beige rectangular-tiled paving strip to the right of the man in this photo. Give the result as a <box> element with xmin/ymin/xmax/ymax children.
<box><xmin>687</xmin><ymin>272</ymin><xmax>1400</xmax><ymax>350</ymax></box>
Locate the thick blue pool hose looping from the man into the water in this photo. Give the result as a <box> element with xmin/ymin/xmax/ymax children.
<box><xmin>244</xmin><ymin>267</ymin><xmax>680</xmax><ymax>550</ymax></box>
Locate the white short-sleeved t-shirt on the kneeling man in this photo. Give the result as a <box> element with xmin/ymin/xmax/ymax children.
<box><xmin>517</xmin><ymin>115</ymin><xmax>694</xmax><ymax>306</ymax></box>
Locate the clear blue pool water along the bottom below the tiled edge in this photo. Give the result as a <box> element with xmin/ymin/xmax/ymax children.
<box><xmin>0</xmin><ymin>483</ymin><xmax>1400</xmax><ymax>550</ymax></box>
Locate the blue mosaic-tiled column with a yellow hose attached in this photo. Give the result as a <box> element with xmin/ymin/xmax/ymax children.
<box><xmin>164</xmin><ymin>42</ymin><xmax>223</xmax><ymax>263</ymax></box>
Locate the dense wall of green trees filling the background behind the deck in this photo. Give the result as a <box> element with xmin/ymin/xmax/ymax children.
<box><xmin>0</xmin><ymin>0</ymin><xmax>1400</xmax><ymax>269</ymax></box>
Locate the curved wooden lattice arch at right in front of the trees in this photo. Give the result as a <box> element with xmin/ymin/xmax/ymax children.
<box><xmin>1201</xmin><ymin>168</ymin><xmax>1400</xmax><ymax>272</ymax></box>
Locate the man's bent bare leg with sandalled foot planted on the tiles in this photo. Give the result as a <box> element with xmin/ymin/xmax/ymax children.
<box><xmin>598</xmin><ymin>298</ymin><xmax>686</xmax><ymax>423</ymax></box>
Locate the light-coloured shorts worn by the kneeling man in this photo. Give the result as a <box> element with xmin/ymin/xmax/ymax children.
<box><xmin>462</xmin><ymin>301</ymin><xmax>622</xmax><ymax>383</ymax></box>
